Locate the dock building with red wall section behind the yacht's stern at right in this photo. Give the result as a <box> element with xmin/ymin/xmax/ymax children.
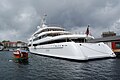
<box><xmin>88</xmin><ymin>31</ymin><xmax>120</xmax><ymax>56</ymax></box>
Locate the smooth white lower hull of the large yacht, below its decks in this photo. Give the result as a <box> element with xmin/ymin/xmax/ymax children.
<box><xmin>29</xmin><ymin>42</ymin><xmax>115</xmax><ymax>60</ymax></box>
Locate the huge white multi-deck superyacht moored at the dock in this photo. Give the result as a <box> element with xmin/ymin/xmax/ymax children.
<box><xmin>28</xmin><ymin>17</ymin><xmax>115</xmax><ymax>60</ymax></box>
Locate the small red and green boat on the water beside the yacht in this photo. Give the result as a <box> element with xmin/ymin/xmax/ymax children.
<box><xmin>13</xmin><ymin>49</ymin><xmax>28</xmax><ymax>62</ymax></box>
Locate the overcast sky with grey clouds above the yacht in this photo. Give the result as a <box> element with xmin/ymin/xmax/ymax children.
<box><xmin>0</xmin><ymin>0</ymin><xmax>120</xmax><ymax>41</ymax></box>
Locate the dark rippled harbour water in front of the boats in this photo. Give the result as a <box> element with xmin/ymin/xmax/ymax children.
<box><xmin>0</xmin><ymin>51</ymin><xmax>120</xmax><ymax>80</ymax></box>
